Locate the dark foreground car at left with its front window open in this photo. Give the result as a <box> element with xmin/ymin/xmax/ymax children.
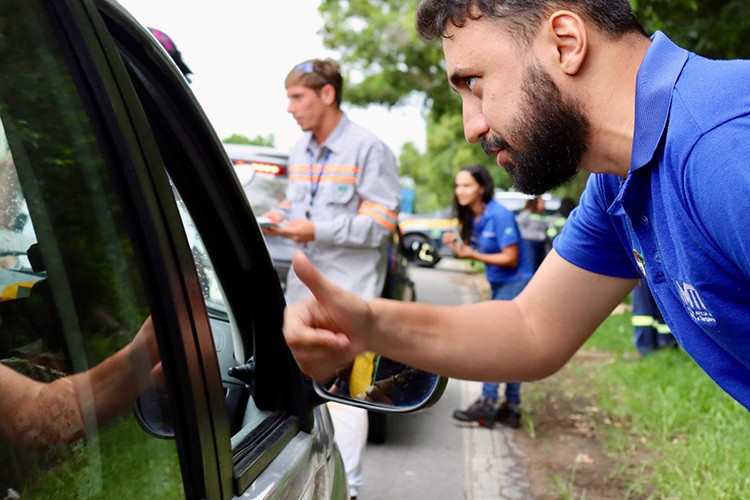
<box><xmin>0</xmin><ymin>0</ymin><xmax>445</xmax><ymax>500</ymax></box>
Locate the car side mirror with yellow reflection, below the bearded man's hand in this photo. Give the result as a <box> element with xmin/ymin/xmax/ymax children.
<box><xmin>315</xmin><ymin>352</ymin><xmax>448</xmax><ymax>413</ymax></box>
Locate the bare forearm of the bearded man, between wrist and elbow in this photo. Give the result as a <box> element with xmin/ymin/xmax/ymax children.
<box><xmin>367</xmin><ymin>299</ymin><xmax>561</xmax><ymax>381</ymax></box>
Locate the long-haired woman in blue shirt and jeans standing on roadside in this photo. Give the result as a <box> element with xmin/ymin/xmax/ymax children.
<box><xmin>443</xmin><ymin>165</ymin><xmax>533</xmax><ymax>428</ymax></box>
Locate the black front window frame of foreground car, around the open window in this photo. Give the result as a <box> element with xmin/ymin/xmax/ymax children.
<box><xmin>93</xmin><ymin>0</ymin><xmax>322</xmax><ymax>494</ymax></box>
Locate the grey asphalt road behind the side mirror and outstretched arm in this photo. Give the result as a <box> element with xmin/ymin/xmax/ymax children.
<box><xmin>358</xmin><ymin>259</ymin><xmax>477</xmax><ymax>500</ymax></box>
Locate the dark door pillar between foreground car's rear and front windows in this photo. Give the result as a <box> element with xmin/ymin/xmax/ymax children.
<box><xmin>46</xmin><ymin>0</ymin><xmax>234</xmax><ymax>498</ymax></box>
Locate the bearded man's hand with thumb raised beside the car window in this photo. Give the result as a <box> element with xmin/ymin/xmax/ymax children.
<box><xmin>284</xmin><ymin>250</ymin><xmax>374</xmax><ymax>382</ymax></box>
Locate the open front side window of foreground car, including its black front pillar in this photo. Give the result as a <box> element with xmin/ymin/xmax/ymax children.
<box><xmin>105</xmin><ymin>12</ymin><xmax>313</xmax><ymax>494</ymax></box>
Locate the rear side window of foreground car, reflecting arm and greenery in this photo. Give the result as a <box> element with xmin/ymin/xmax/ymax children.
<box><xmin>0</xmin><ymin>0</ymin><xmax>184</xmax><ymax>499</ymax></box>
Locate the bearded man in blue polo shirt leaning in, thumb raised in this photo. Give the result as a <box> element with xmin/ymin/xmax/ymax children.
<box><xmin>284</xmin><ymin>0</ymin><xmax>750</xmax><ymax>414</ymax></box>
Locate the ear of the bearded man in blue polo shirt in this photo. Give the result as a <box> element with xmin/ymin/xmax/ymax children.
<box><xmin>547</xmin><ymin>10</ymin><xmax>589</xmax><ymax>75</ymax></box>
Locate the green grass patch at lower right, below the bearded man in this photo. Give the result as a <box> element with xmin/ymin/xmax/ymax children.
<box><xmin>572</xmin><ymin>312</ymin><xmax>750</xmax><ymax>500</ymax></box>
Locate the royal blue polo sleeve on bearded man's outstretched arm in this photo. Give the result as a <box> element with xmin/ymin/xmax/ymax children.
<box><xmin>553</xmin><ymin>174</ymin><xmax>638</xmax><ymax>278</ymax></box>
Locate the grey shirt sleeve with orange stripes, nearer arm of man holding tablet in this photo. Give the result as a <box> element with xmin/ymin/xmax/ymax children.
<box><xmin>315</xmin><ymin>141</ymin><xmax>401</xmax><ymax>248</ymax></box>
